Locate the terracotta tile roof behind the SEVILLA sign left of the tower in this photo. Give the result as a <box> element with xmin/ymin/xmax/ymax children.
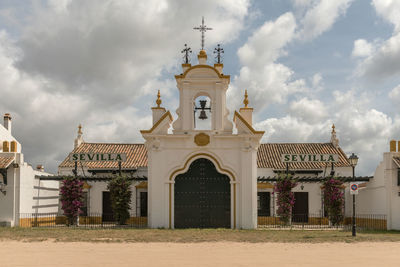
<box><xmin>59</xmin><ymin>143</ymin><xmax>147</xmax><ymax>169</ymax></box>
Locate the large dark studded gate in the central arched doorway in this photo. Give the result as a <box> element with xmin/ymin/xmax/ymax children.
<box><xmin>174</xmin><ymin>158</ymin><xmax>231</xmax><ymax>228</ymax></box>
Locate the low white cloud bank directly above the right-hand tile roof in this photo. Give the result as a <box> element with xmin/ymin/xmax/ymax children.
<box><xmin>255</xmin><ymin>88</ymin><xmax>400</xmax><ymax>175</ymax></box>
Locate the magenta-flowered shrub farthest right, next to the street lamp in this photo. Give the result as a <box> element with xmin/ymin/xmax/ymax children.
<box><xmin>323</xmin><ymin>177</ymin><xmax>344</xmax><ymax>225</ymax></box>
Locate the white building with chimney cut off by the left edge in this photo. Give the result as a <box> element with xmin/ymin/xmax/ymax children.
<box><xmin>0</xmin><ymin>113</ymin><xmax>58</xmax><ymax>226</ymax></box>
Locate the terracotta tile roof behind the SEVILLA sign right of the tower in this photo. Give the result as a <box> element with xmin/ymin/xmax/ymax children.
<box><xmin>257</xmin><ymin>143</ymin><xmax>350</xmax><ymax>170</ymax></box>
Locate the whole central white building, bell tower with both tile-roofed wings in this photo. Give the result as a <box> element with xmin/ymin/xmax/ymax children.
<box><xmin>58</xmin><ymin>50</ymin><xmax>369</xmax><ymax>229</ymax></box>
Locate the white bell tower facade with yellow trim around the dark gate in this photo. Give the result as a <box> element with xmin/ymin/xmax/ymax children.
<box><xmin>141</xmin><ymin>38</ymin><xmax>264</xmax><ymax>229</ymax></box>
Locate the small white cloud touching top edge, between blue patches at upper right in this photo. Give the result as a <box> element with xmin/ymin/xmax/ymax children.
<box><xmin>296</xmin><ymin>0</ymin><xmax>354</xmax><ymax>40</ymax></box>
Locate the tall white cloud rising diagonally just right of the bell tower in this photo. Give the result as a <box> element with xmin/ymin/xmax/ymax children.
<box><xmin>228</xmin><ymin>13</ymin><xmax>305</xmax><ymax>110</ymax></box>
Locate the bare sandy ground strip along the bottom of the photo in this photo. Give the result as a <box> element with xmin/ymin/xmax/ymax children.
<box><xmin>0</xmin><ymin>241</ymin><xmax>400</xmax><ymax>267</ymax></box>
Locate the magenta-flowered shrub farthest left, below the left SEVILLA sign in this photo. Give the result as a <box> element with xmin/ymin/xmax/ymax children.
<box><xmin>60</xmin><ymin>178</ymin><xmax>83</xmax><ymax>225</ymax></box>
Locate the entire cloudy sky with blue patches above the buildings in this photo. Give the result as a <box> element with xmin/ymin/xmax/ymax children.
<box><xmin>0</xmin><ymin>0</ymin><xmax>400</xmax><ymax>175</ymax></box>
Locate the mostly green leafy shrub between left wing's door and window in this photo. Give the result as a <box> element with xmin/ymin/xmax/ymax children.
<box><xmin>107</xmin><ymin>176</ymin><xmax>132</xmax><ymax>225</ymax></box>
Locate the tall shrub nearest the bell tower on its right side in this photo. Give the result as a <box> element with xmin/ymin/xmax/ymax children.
<box><xmin>274</xmin><ymin>175</ymin><xmax>297</xmax><ymax>224</ymax></box>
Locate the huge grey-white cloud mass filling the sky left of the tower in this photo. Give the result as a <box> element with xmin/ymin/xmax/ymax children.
<box><xmin>0</xmin><ymin>0</ymin><xmax>249</xmax><ymax>171</ymax></box>
